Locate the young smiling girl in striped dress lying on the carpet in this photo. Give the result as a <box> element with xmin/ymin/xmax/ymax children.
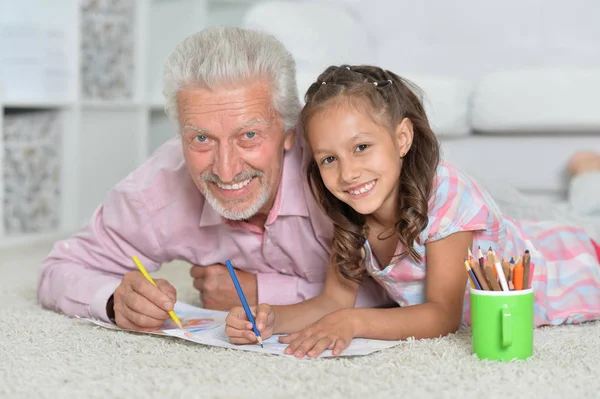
<box><xmin>226</xmin><ymin>66</ymin><xmax>600</xmax><ymax>357</ymax></box>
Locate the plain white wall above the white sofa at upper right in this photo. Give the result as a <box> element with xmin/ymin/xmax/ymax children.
<box><xmin>319</xmin><ymin>0</ymin><xmax>600</xmax><ymax>78</ymax></box>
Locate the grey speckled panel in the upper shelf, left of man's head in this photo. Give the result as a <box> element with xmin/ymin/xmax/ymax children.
<box><xmin>81</xmin><ymin>0</ymin><xmax>136</xmax><ymax>101</ymax></box>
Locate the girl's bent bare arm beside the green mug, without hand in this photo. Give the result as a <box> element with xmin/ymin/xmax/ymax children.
<box><xmin>347</xmin><ymin>232</ymin><xmax>473</xmax><ymax>340</ymax></box>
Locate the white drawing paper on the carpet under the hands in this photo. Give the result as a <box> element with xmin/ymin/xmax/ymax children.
<box><xmin>84</xmin><ymin>302</ymin><xmax>400</xmax><ymax>357</ymax></box>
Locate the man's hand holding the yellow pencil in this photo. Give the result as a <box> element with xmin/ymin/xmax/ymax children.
<box><xmin>114</xmin><ymin>271</ymin><xmax>177</xmax><ymax>331</ymax></box>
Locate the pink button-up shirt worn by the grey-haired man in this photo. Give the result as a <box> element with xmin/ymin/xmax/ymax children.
<box><xmin>38</xmin><ymin>138</ymin><xmax>390</xmax><ymax>320</ymax></box>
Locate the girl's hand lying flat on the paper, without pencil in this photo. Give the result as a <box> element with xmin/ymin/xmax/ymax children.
<box><xmin>279</xmin><ymin>309</ymin><xmax>356</xmax><ymax>358</ymax></box>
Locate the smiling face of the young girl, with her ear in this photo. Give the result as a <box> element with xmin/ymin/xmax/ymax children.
<box><xmin>307</xmin><ymin>105</ymin><xmax>412</xmax><ymax>221</ymax></box>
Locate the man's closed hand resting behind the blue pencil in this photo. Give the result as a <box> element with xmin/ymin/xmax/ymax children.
<box><xmin>190</xmin><ymin>263</ymin><xmax>258</xmax><ymax>311</ymax></box>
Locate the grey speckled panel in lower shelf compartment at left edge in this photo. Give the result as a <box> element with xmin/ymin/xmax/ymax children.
<box><xmin>2</xmin><ymin>111</ymin><xmax>62</xmax><ymax>235</ymax></box>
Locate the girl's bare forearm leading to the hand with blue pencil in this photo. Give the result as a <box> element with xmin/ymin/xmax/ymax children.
<box><xmin>271</xmin><ymin>266</ymin><xmax>359</xmax><ymax>334</ymax></box>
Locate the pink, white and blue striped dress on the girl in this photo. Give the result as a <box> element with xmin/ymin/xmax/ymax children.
<box><xmin>365</xmin><ymin>162</ymin><xmax>600</xmax><ymax>326</ymax></box>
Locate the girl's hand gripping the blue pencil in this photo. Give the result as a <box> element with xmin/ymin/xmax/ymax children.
<box><xmin>225</xmin><ymin>304</ymin><xmax>275</xmax><ymax>345</ymax></box>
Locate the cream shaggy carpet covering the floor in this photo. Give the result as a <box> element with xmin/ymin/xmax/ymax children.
<box><xmin>0</xmin><ymin>239</ymin><xmax>600</xmax><ymax>399</ymax></box>
